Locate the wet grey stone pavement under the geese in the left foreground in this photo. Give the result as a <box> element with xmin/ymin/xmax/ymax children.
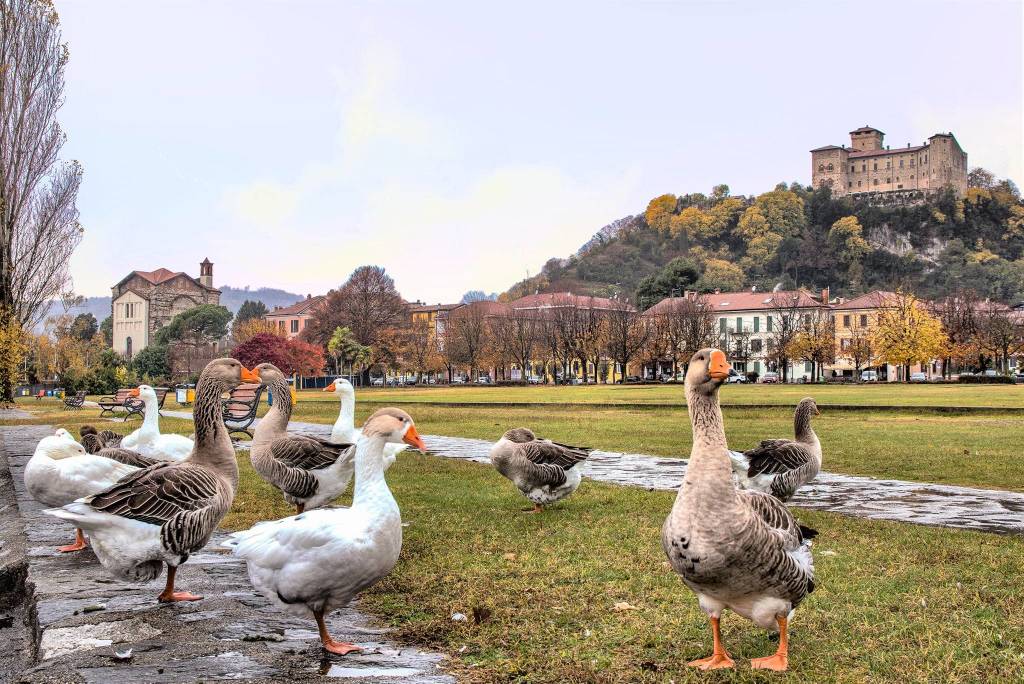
<box><xmin>0</xmin><ymin>426</ymin><xmax>455</xmax><ymax>684</ymax></box>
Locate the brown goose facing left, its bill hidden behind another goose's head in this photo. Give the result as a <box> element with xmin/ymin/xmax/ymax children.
<box><xmin>250</xmin><ymin>364</ymin><xmax>354</xmax><ymax>513</ymax></box>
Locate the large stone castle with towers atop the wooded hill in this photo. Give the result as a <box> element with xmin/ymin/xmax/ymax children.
<box><xmin>811</xmin><ymin>126</ymin><xmax>967</xmax><ymax>197</ymax></box>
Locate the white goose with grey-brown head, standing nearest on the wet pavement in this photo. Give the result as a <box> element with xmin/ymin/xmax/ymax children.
<box><xmin>225</xmin><ymin>409</ymin><xmax>426</xmax><ymax>655</ymax></box>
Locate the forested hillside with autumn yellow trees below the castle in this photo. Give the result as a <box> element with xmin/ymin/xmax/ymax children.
<box><xmin>506</xmin><ymin>169</ymin><xmax>1024</xmax><ymax>304</ymax></box>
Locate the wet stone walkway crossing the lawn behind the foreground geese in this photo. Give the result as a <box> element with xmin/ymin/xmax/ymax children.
<box><xmin>164</xmin><ymin>412</ymin><xmax>1024</xmax><ymax>535</ymax></box>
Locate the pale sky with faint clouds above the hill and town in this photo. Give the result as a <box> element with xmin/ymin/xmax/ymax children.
<box><xmin>56</xmin><ymin>0</ymin><xmax>1024</xmax><ymax>302</ymax></box>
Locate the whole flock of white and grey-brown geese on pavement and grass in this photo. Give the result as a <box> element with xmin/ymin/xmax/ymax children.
<box><xmin>25</xmin><ymin>349</ymin><xmax>821</xmax><ymax>670</ymax></box>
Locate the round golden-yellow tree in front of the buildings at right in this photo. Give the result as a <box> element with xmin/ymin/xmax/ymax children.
<box><xmin>871</xmin><ymin>292</ymin><xmax>948</xmax><ymax>380</ymax></box>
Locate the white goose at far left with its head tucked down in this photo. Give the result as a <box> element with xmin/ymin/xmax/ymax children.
<box><xmin>25</xmin><ymin>430</ymin><xmax>138</xmax><ymax>553</ymax></box>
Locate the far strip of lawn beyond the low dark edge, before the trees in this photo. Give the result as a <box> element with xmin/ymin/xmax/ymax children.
<box><xmin>300</xmin><ymin>383</ymin><xmax>1024</xmax><ymax>409</ymax></box>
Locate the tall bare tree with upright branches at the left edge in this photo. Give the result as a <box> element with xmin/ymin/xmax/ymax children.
<box><xmin>0</xmin><ymin>0</ymin><xmax>82</xmax><ymax>402</ymax></box>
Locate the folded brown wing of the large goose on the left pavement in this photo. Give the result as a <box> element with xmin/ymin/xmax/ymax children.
<box><xmin>88</xmin><ymin>462</ymin><xmax>221</xmax><ymax>525</ymax></box>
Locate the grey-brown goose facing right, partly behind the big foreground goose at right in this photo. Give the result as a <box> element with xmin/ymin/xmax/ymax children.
<box><xmin>729</xmin><ymin>397</ymin><xmax>821</xmax><ymax>501</ymax></box>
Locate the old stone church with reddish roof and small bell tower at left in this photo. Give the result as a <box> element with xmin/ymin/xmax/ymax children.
<box><xmin>111</xmin><ymin>259</ymin><xmax>220</xmax><ymax>358</ymax></box>
